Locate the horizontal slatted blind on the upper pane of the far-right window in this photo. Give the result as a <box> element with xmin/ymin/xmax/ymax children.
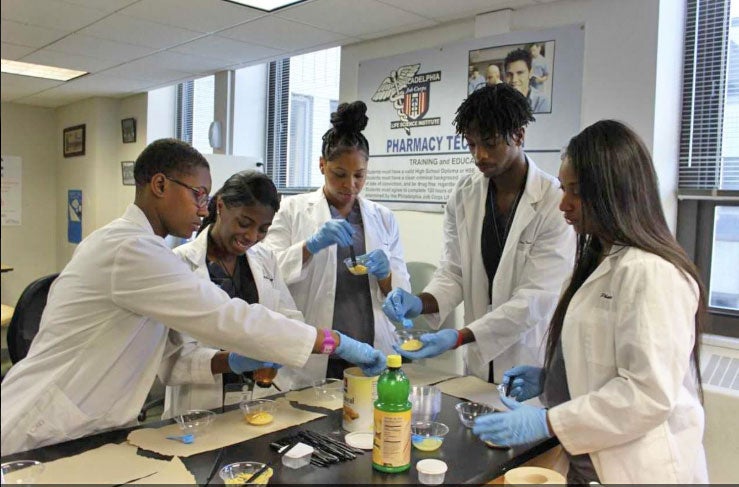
<box><xmin>679</xmin><ymin>0</ymin><xmax>739</xmax><ymax>190</ymax></box>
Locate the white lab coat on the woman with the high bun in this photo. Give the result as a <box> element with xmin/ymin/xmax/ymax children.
<box><xmin>262</xmin><ymin>188</ymin><xmax>410</xmax><ymax>387</ymax></box>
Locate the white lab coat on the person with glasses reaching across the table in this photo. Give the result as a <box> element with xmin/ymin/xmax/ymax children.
<box><xmin>0</xmin><ymin>205</ymin><xmax>316</xmax><ymax>455</ymax></box>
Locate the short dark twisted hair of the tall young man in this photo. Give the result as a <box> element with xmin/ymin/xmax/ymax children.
<box><xmin>452</xmin><ymin>83</ymin><xmax>535</xmax><ymax>143</ymax></box>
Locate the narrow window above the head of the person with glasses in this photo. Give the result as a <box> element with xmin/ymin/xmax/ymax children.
<box><xmin>175</xmin><ymin>76</ymin><xmax>215</xmax><ymax>154</ymax></box>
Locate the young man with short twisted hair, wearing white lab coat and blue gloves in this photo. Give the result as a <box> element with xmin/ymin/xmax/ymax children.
<box><xmin>383</xmin><ymin>83</ymin><xmax>575</xmax><ymax>383</ymax></box>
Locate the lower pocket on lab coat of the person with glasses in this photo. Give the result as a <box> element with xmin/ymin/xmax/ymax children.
<box><xmin>22</xmin><ymin>384</ymin><xmax>92</xmax><ymax>446</ymax></box>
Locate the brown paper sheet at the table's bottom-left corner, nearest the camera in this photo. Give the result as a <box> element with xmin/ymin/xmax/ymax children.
<box><xmin>27</xmin><ymin>443</ymin><xmax>165</xmax><ymax>485</ymax></box>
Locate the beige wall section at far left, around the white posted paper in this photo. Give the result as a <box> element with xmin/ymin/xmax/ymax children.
<box><xmin>0</xmin><ymin>103</ymin><xmax>58</xmax><ymax>306</ymax></box>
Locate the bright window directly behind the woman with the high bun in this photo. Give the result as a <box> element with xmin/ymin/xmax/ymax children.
<box><xmin>265</xmin><ymin>47</ymin><xmax>341</xmax><ymax>192</ymax></box>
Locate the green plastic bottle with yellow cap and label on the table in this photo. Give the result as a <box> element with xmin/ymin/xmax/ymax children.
<box><xmin>372</xmin><ymin>355</ymin><xmax>411</xmax><ymax>473</ymax></box>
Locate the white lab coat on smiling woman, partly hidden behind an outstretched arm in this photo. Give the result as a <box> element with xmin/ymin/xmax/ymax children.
<box><xmin>159</xmin><ymin>227</ymin><xmax>303</xmax><ymax>418</ymax></box>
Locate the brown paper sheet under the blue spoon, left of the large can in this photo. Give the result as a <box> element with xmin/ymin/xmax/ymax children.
<box><xmin>128</xmin><ymin>398</ymin><xmax>325</xmax><ymax>457</ymax></box>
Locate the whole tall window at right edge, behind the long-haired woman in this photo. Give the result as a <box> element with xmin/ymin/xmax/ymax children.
<box><xmin>678</xmin><ymin>0</ymin><xmax>739</xmax><ymax>336</ymax></box>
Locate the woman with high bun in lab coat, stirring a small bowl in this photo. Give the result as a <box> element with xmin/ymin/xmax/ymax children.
<box><xmin>264</xmin><ymin>101</ymin><xmax>410</xmax><ymax>386</ymax></box>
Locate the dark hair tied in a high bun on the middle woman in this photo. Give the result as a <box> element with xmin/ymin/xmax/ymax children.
<box><xmin>321</xmin><ymin>100</ymin><xmax>369</xmax><ymax>161</ymax></box>
